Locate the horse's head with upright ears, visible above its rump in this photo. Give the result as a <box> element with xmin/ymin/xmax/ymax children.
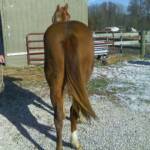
<box><xmin>52</xmin><ymin>4</ymin><xmax>70</xmax><ymax>23</ymax></box>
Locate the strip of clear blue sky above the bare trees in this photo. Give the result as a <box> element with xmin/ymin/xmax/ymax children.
<box><xmin>88</xmin><ymin>0</ymin><xmax>129</xmax><ymax>6</ymax></box>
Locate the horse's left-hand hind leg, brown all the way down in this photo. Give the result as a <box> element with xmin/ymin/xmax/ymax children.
<box><xmin>50</xmin><ymin>80</ymin><xmax>64</xmax><ymax>150</ymax></box>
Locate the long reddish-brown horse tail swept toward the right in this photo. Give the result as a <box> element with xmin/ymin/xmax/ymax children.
<box><xmin>64</xmin><ymin>35</ymin><xmax>96</xmax><ymax>119</ymax></box>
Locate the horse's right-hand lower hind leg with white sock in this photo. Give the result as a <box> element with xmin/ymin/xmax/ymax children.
<box><xmin>70</xmin><ymin>102</ymin><xmax>82</xmax><ymax>150</ymax></box>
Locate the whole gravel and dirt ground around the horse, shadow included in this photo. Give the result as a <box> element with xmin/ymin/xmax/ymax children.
<box><xmin>0</xmin><ymin>59</ymin><xmax>150</xmax><ymax>150</ymax></box>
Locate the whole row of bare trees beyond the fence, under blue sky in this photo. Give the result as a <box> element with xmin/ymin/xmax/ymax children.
<box><xmin>89</xmin><ymin>0</ymin><xmax>150</xmax><ymax>31</ymax></box>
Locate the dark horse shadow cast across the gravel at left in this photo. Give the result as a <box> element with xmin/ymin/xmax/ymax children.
<box><xmin>0</xmin><ymin>77</ymin><xmax>70</xmax><ymax>150</ymax></box>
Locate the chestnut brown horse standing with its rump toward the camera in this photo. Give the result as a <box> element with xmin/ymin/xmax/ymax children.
<box><xmin>44</xmin><ymin>6</ymin><xmax>96</xmax><ymax>150</ymax></box>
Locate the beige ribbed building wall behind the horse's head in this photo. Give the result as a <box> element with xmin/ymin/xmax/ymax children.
<box><xmin>0</xmin><ymin>0</ymin><xmax>88</xmax><ymax>66</ymax></box>
